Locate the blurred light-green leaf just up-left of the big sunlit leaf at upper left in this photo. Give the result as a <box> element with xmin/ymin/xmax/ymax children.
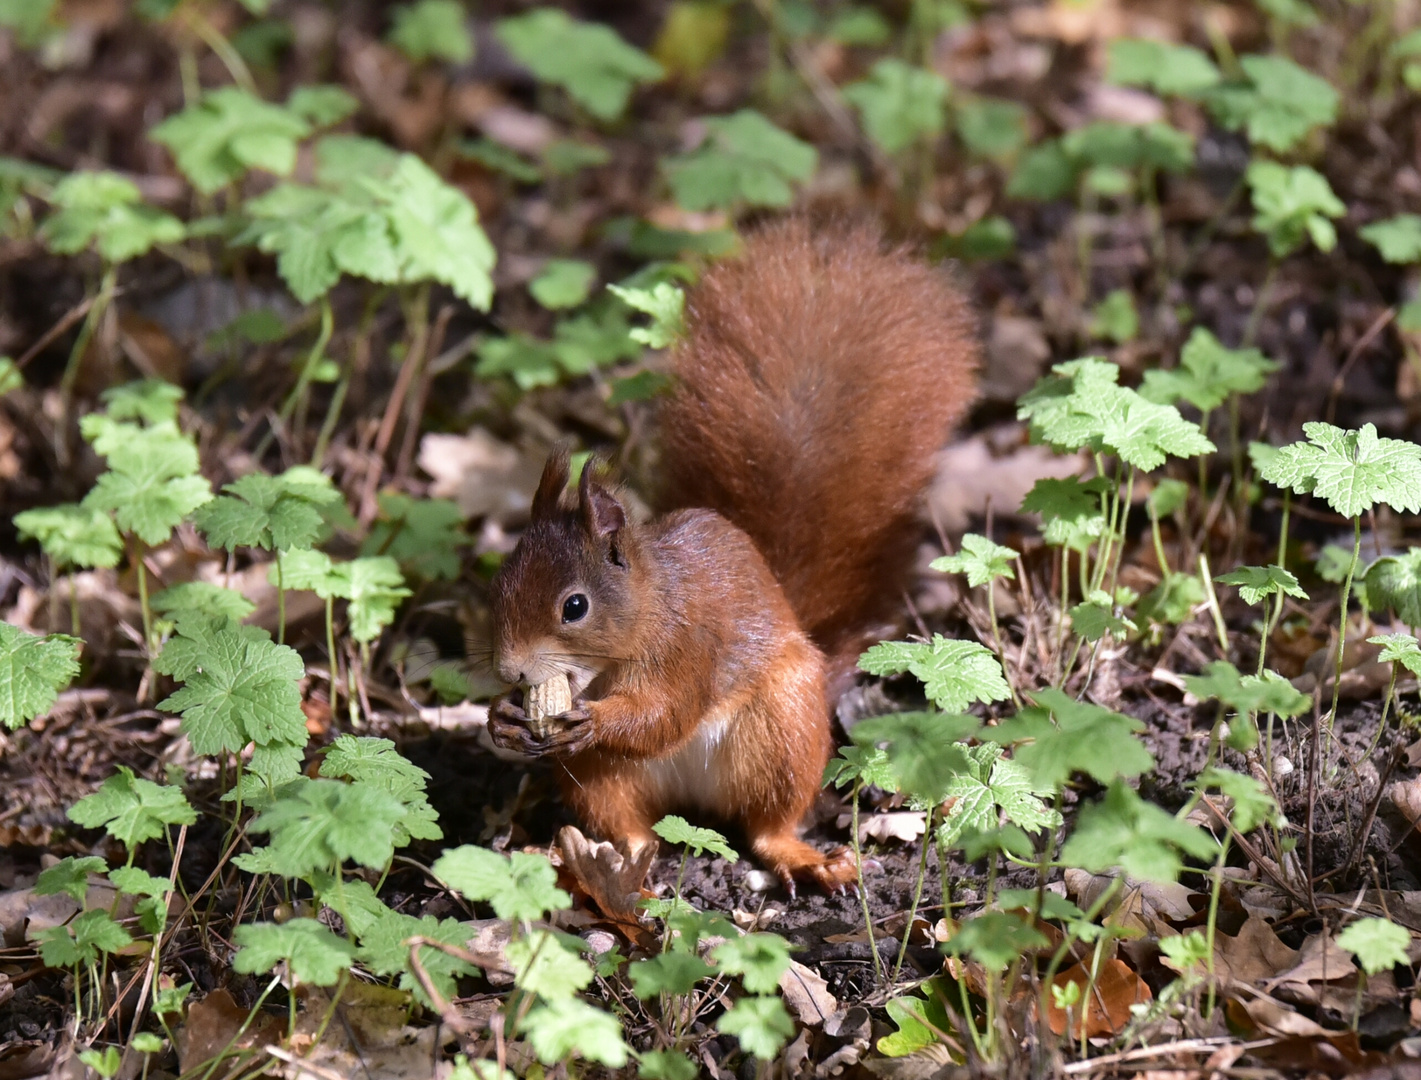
<box><xmin>149</xmin><ymin>87</ymin><xmax>311</xmax><ymax>195</ymax></box>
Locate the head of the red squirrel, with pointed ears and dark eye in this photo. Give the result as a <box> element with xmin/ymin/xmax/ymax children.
<box><xmin>492</xmin><ymin>449</ymin><xmax>635</xmax><ymax>695</ymax></box>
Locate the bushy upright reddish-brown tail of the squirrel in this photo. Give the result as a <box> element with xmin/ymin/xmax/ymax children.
<box><xmin>659</xmin><ymin>219</ymin><xmax>979</xmax><ymax>675</ymax></box>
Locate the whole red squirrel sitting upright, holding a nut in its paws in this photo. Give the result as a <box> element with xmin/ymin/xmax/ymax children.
<box><xmin>490</xmin><ymin>219</ymin><xmax>979</xmax><ymax>891</ymax></box>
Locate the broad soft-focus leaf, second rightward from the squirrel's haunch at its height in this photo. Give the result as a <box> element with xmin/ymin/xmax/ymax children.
<box><xmin>980</xmin><ymin>689</ymin><xmax>1154</xmax><ymax>792</ymax></box>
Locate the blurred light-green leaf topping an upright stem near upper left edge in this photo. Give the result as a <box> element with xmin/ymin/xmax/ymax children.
<box><xmin>40</xmin><ymin>172</ymin><xmax>186</xmax><ymax>263</ymax></box>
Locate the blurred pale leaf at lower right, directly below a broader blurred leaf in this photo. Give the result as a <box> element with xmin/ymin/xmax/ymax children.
<box><xmin>1061</xmin><ymin>780</ymin><xmax>1218</xmax><ymax>882</ymax></box>
